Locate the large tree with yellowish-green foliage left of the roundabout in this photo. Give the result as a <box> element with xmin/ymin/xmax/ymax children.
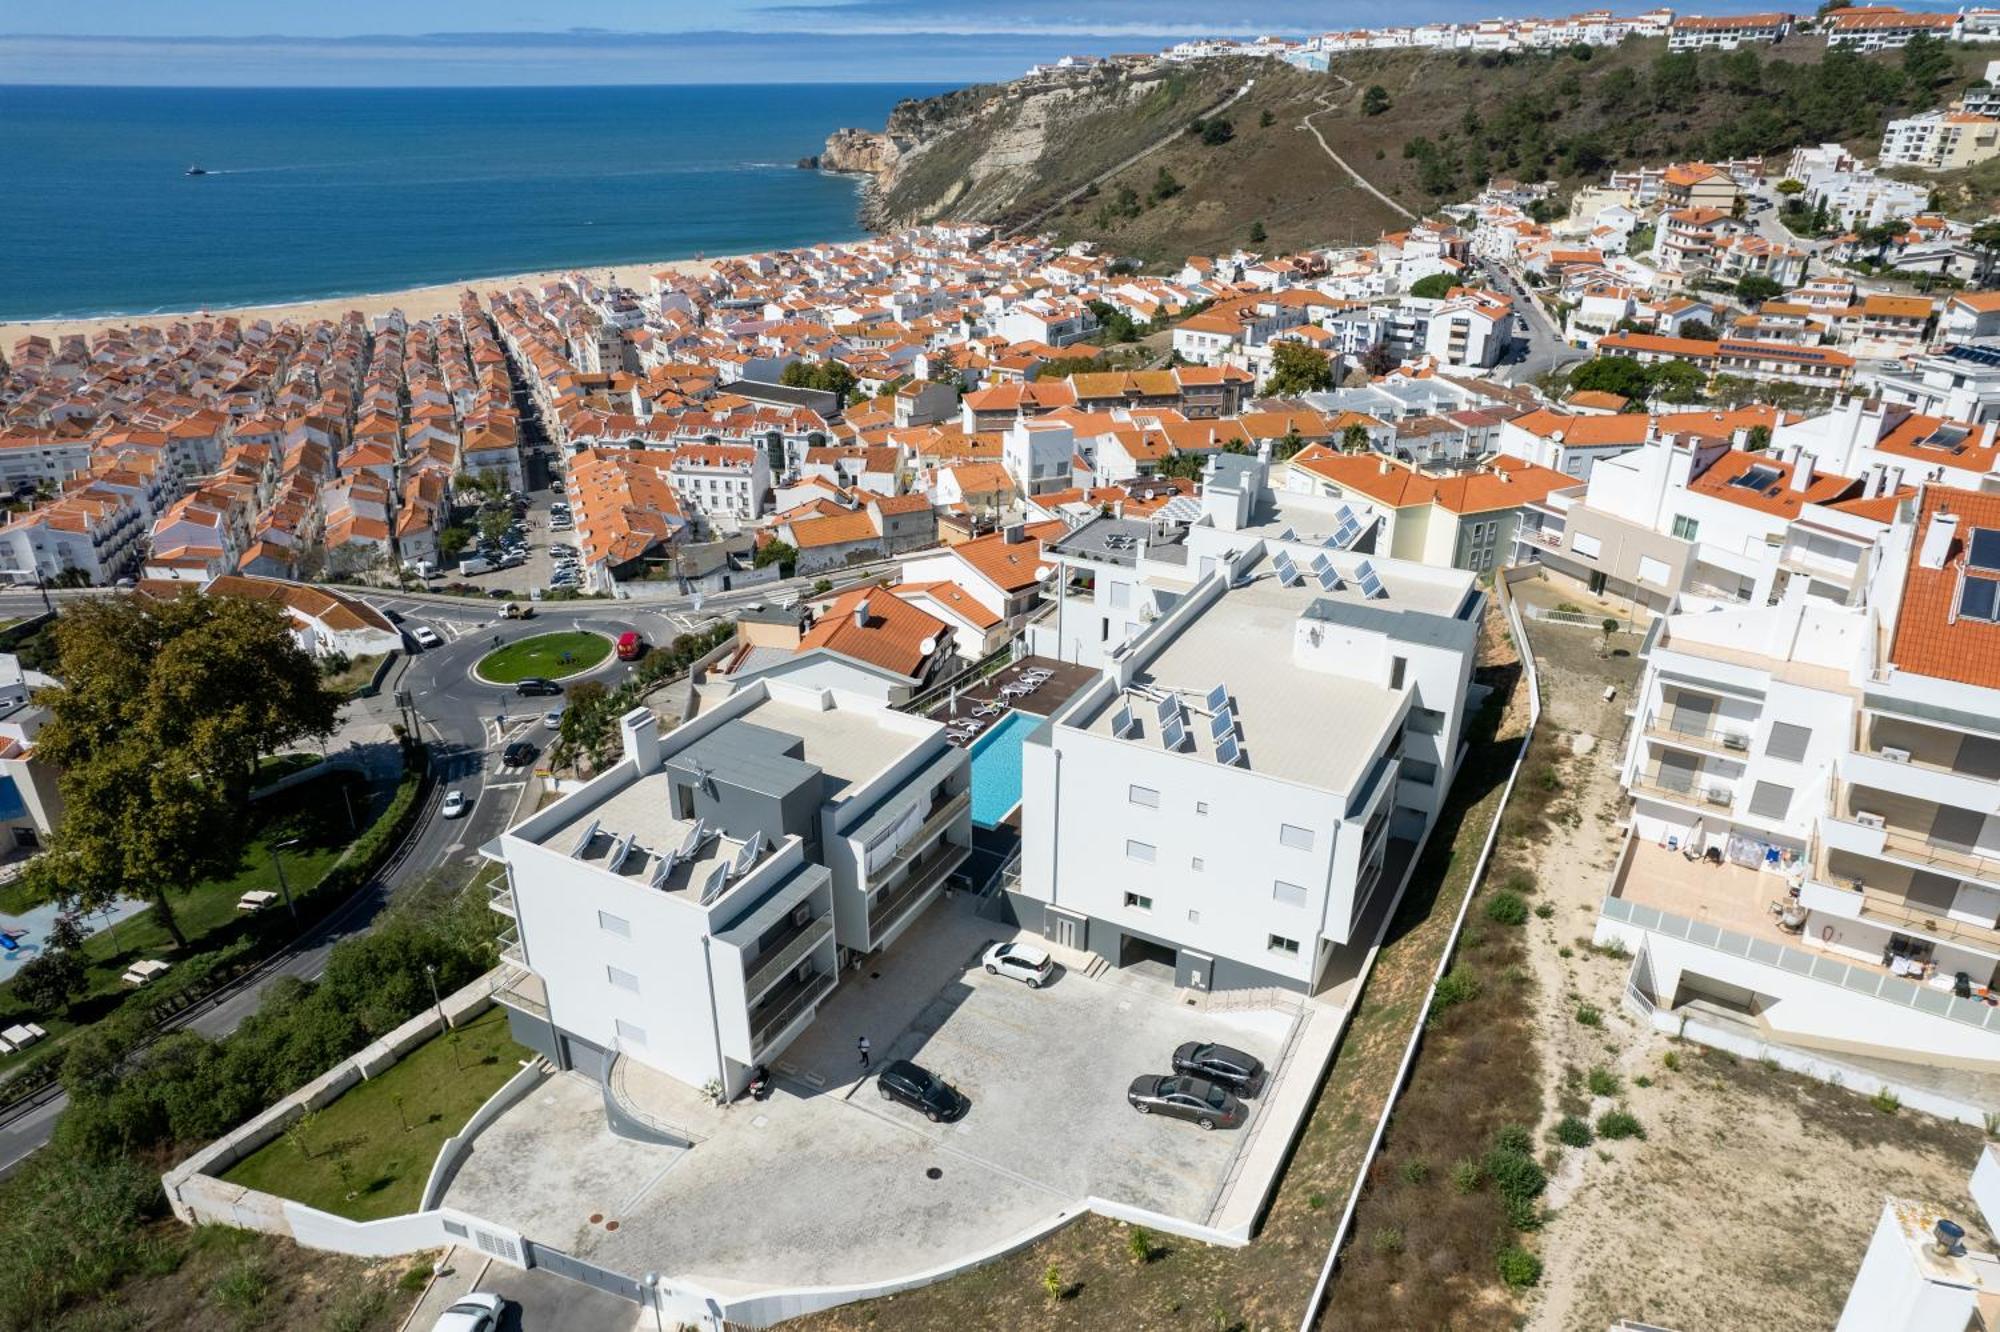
<box><xmin>30</xmin><ymin>588</ymin><xmax>340</xmax><ymax>946</ymax></box>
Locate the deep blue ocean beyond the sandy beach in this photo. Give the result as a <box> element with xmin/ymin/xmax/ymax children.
<box><xmin>0</xmin><ymin>84</ymin><xmax>936</xmax><ymax>320</ymax></box>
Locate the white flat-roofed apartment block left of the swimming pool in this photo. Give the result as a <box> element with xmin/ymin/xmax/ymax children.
<box><xmin>486</xmin><ymin>680</ymin><xmax>972</xmax><ymax>1094</ymax></box>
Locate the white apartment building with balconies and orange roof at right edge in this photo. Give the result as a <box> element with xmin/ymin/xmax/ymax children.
<box><xmin>1598</xmin><ymin>486</ymin><xmax>2000</xmax><ymax>1096</ymax></box>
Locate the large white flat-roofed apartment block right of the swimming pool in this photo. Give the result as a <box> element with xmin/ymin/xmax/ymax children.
<box><xmin>1006</xmin><ymin>528</ymin><xmax>1486</xmax><ymax>992</ymax></box>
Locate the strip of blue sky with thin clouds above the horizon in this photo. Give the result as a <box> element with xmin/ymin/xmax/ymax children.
<box><xmin>0</xmin><ymin>0</ymin><xmax>1918</xmax><ymax>86</ymax></box>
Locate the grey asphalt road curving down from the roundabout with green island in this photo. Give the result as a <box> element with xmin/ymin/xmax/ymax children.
<box><xmin>0</xmin><ymin>566</ymin><xmax>896</xmax><ymax>1174</ymax></box>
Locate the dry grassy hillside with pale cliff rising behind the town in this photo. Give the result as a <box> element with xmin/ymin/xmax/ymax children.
<box><xmin>872</xmin><ymin>40</ymin><xmax>1988</xmax><ymax>262</ymax></box>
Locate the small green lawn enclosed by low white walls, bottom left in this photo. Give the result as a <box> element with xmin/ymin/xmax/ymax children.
<box><xmin>222</xmin><ymin>1006</ymin><xmax>532</xmax><ymax>1220</ymax></box>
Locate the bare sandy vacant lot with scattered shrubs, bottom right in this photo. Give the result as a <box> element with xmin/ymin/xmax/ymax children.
<box><xmin>1526</xmin><ymin>588</ymin><xmax>1984</xmax><ymax>1332</ymax></box>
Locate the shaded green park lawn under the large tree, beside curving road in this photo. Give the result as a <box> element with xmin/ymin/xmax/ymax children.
<box><xmin>0</xmin><ymin>774</ymin><xmax>386</xmax><ymax>1072</ymax></box>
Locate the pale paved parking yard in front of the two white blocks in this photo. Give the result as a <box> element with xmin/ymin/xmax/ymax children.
<box><xmin>446</xmin><ymin>900</ymin><xmax>1290</xmax><ymax>1288</ymax></box>
